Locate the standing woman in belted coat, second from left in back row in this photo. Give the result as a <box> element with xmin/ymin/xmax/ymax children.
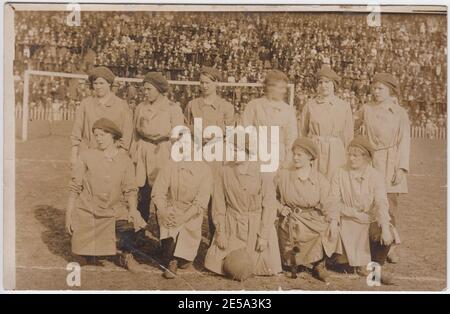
<box><xmin>131</xmin><ymin>72</ymin><xmax>184</xmax><ymax>219</ymax></box>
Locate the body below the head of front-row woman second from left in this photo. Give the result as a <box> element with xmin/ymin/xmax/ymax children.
<box><xmin>152</xmin><ymin>136</ymin><xmax>213</xmax><ymax>279</ymax></box>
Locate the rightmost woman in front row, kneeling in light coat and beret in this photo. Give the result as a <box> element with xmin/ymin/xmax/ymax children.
<box><xmin>331</xmin><ymin>136</ymin><xmax>399</xmax><ymax>284</ymax></box>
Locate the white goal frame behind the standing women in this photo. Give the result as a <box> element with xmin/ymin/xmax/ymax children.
<box><xmin>22</xmin><ymin>70</ymin><xmax>295</xmax><ymax>141</ymax></box>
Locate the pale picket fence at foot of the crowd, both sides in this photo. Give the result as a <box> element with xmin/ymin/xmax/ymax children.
<box><xmin>16</xmin><ymin>106</ymin><xmax>447</xmax><ymax>140</ymax></box>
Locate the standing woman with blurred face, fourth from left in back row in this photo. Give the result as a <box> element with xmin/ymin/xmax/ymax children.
<box><xmin>242</xmin><ymin>70</ymin><xmax>298</xmax><ymax>169</ymax></box>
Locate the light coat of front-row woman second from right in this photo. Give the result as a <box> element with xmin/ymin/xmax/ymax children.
<box><xmin>275</xmin><ymin>168</ymin><xmax>342</xmax><ymax>265</ymax></box>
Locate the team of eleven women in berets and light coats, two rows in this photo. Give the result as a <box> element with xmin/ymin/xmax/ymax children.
<box><xmin>66</xmin><ymin>65</ymin><xmax>410</xmax><ymax>284</ymax></box>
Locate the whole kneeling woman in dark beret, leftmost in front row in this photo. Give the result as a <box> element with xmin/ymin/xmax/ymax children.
<box><xmin>66</xmin><ymin>118</ymin><xmax>146</xmax><ymax>271</ymax></box>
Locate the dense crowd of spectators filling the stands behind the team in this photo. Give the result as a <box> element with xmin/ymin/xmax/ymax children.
<box><xmin>14</xmin><ymin>11</ymin><xmax>447</xmax><ymax>126</ymax></box>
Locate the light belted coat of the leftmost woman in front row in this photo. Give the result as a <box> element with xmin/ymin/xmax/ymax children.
<box><xmin>70</xmin><ymin>149</ymin><xmax>137</xmax><ymax>256</ymax></box>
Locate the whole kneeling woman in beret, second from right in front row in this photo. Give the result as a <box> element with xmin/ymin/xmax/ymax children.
<box><xmin>275</xmin><ymin>137</ymin><xmax>342</xmax><ymax>281</ymax></box>
